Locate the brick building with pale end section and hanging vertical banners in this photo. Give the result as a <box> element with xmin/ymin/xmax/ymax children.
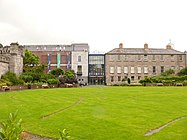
<box><xmin>24</xmin><ymin>43</ymin><xmax>89</xmax><ymax>83</ymax></box>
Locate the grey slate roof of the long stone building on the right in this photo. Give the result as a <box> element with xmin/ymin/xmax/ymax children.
<box><xmin>106</xmin><ymin>48</ymin><xmax>184</xmax><ymax>55</ymax></box>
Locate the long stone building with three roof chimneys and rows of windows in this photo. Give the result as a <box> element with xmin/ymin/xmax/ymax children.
<box><xmin>105</xmin><ymin>43</ymin><xmax>187</xmax><ymax>85</ymax></box>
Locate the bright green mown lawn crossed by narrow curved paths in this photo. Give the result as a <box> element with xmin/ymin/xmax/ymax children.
<box><xmin>0</xmin><ymin>87</ymin><xmax>187</xmax><ymax>140</ymax></box>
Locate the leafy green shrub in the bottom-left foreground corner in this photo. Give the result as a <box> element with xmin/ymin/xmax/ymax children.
<box><xmin>0</xmin><ymin>112</ymin><xmax>22</xmax><ymax>140</ymax></box>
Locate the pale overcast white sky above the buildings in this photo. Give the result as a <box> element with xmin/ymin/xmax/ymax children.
<box><xmin>0</xmin><ymin>0</ymin><xmax>187</xmax><ymax>52</ymax></box>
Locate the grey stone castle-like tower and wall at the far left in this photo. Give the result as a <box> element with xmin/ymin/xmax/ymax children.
<box><xmin>0</xmin><ymin>43</ymin><xmax>24</xmax><ymax>77</ymax></box>
